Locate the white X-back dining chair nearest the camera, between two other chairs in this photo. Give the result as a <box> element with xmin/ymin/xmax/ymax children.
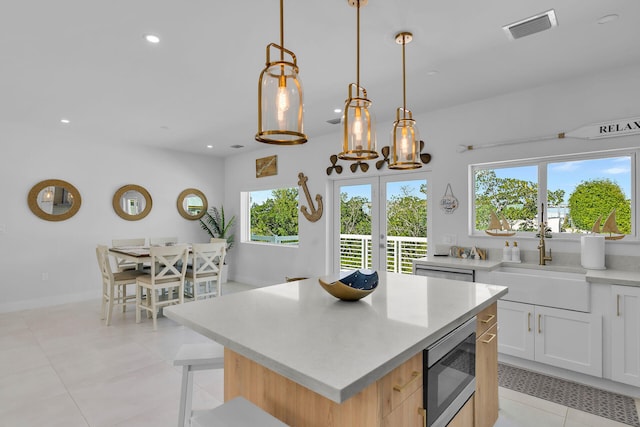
<box><xmin>136</xmin><ymin>245</ymin><xmax>189</xmax><ymax>331</ymax></box>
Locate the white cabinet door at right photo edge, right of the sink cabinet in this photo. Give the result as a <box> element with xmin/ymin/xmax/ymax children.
<box><xmin>611</xmin><ymin>285</ymin><xmax>640</xmax><ymax>387</ymax></box>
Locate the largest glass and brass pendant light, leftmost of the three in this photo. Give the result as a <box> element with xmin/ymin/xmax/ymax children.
<box><xmin>256</xmin><ymin>0</ymin><xmax>307</xmax><ymax>145</ymax></box>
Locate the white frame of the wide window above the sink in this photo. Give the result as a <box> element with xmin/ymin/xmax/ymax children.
<box><xmin>467</xmin><ymin>148</ymin><xmax>640</xmax><ymax>243</ymax></box>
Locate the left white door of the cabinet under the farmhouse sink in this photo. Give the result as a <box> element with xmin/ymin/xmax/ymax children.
<box><xmin>498</xmin><ymin>301</ymin><xmax>535</xmax><ymax>360</ymax></box>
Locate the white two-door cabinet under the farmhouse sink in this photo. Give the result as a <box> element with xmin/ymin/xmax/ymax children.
<box><xmin>498</xmin><ymin>301</ymin><xmax>602</xmax><ymax>377</ymax></box>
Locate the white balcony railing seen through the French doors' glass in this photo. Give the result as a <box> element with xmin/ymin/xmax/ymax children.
<box><xmin>340</xmin><ymin>234</ymin><xmax>427</xmax><ymax>274</ymax></box>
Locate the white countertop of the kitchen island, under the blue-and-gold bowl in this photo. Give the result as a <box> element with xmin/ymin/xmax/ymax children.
<box><xmin>164</xmin><ymin>273</ymin><xmax>507</xmax><ymax>403</ymax></box>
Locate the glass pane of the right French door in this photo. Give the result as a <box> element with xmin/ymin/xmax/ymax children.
<box><xmin>385</xmin><ymin>179</ymin><xmax>427</xmax><ymax>274</ymax></box>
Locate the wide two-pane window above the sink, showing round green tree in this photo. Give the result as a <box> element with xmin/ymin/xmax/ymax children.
<box><xmin>470</xmin><ymin>150</ymin><xmax>637</xmax><ymax>237</ymax></box>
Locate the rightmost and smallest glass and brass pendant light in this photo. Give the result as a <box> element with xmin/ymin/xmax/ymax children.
<box><xmin>389</xmin><ymin>32</ymin><xmax>422</xmax><ymax>169</ymax></box>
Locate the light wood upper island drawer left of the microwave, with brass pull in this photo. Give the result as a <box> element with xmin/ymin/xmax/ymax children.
<box><xmin>380</xmin><ymin>352</ymin><xmax>424</xmax><ymax>417</ymax></box>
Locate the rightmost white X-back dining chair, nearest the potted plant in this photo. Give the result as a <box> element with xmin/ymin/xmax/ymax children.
<box><xmin>185</xmin><ymin>239</ymin><xmax>227</xmax><ymax>301</ymax></box>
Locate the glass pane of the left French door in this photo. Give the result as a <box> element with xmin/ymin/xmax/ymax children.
<box><xmin>340</xmin><ymin>184</ymin><xmax>372</xmax><ymax>270</ymax></box>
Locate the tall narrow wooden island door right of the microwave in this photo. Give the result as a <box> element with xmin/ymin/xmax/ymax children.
<box><xmin>475</xmin><ymin>324</ymin><xmax>498</xmax><ymax>427</ymax></box>
